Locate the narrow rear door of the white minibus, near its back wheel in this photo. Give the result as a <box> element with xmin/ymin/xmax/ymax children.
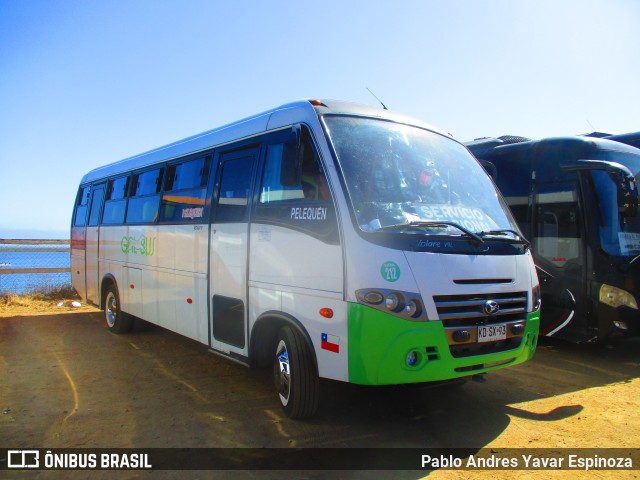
<box><xmin>85</xmin><ymin>183</ymin><xmax>106</xmax><ymax>305</ymax></box>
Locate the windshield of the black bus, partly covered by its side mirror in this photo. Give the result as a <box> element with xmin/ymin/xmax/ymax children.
<box><xmin>591</xmin><ymin>150</ymin><xmax>640</xmax><ymax>257</ymax></box>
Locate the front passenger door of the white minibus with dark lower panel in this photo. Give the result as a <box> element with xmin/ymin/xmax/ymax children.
<box><xmin>209</xmin><ymin>148</ymin><xmax>260</xmax><ymax>357</ymax></box>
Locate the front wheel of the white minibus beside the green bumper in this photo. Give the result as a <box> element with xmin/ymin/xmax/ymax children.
<box><xmin>273</xmin><ymin>327</ymin><xmax>320</xmax><ymax>418</ymax></box>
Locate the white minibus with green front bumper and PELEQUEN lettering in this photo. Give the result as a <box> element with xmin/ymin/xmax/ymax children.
<box><xmin>71</xmin><ymin>100</ymin><xmax>540</xmax><ymax>418</ymax></box>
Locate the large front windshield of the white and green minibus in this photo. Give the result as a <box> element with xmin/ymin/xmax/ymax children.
<box><xmin>323</xmin><ymin>115</ymin><xmax>519</xmax><ymax>236</ymax></box>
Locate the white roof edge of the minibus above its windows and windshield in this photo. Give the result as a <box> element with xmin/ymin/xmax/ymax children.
<box><xmin>81</xmin><ymin>100</ymin><xmax>451</xmax><ymax>184</ymax></box>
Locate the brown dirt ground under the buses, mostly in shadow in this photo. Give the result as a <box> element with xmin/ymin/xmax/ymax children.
<box><xmin>0</xmin><ymin>307</ymin><xmax>640</xmax><ymax>480</ymax></box>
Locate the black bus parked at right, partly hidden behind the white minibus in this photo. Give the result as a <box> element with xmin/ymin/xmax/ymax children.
<box><xmin>467</xmin><ymin>137</ymin><xmax>640</xmax><ymax>342</ymax></box>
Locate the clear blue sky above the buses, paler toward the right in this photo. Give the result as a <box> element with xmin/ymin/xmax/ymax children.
<box><xmin>0</xmin><ymin>0</ymin><xmax>640</xmax><ymax>238</ymax></box>
